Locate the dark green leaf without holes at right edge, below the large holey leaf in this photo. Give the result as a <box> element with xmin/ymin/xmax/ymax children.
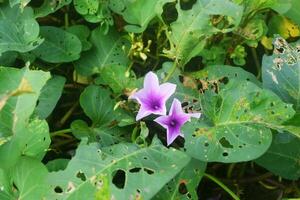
<box><xmin>255</xmin><ymin>133</ymin><xmax>300</xmax><ymax>180</ymax></box>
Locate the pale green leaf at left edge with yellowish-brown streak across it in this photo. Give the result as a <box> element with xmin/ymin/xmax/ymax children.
<box><xmin>0</xmin><ymin>67</ymin><xmax>50</xmax><ymax>137</ymax></box>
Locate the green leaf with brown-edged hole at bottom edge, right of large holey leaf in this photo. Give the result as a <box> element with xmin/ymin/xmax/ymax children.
<box><xmin>155</xmin><ymin>159</ymin><xmax>206</xmax><ymax>200</ymax></box>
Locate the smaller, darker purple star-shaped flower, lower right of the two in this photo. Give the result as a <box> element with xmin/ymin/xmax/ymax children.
<box><xmin>154</xmin><ymin>99</ymin><xmax>201</xmax><ymax>146</ymax></box>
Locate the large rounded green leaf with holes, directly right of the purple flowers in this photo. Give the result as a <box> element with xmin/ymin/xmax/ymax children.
<box><xmin>183</xmin><ymin>80</ymin><xmax>295</xmax><ymax>163</ymax></box>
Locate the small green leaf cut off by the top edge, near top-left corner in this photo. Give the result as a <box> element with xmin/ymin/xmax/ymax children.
<box><xmin>34</xmin><ymin>0</ymin><xmax>72</xmax><ymax>17</ymax></box>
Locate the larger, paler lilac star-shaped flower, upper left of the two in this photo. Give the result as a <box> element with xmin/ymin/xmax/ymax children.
<box><xmin>129</xmin><ymin>72</ymin><xmax>176</xmax><ymax>120</ymax></box>
